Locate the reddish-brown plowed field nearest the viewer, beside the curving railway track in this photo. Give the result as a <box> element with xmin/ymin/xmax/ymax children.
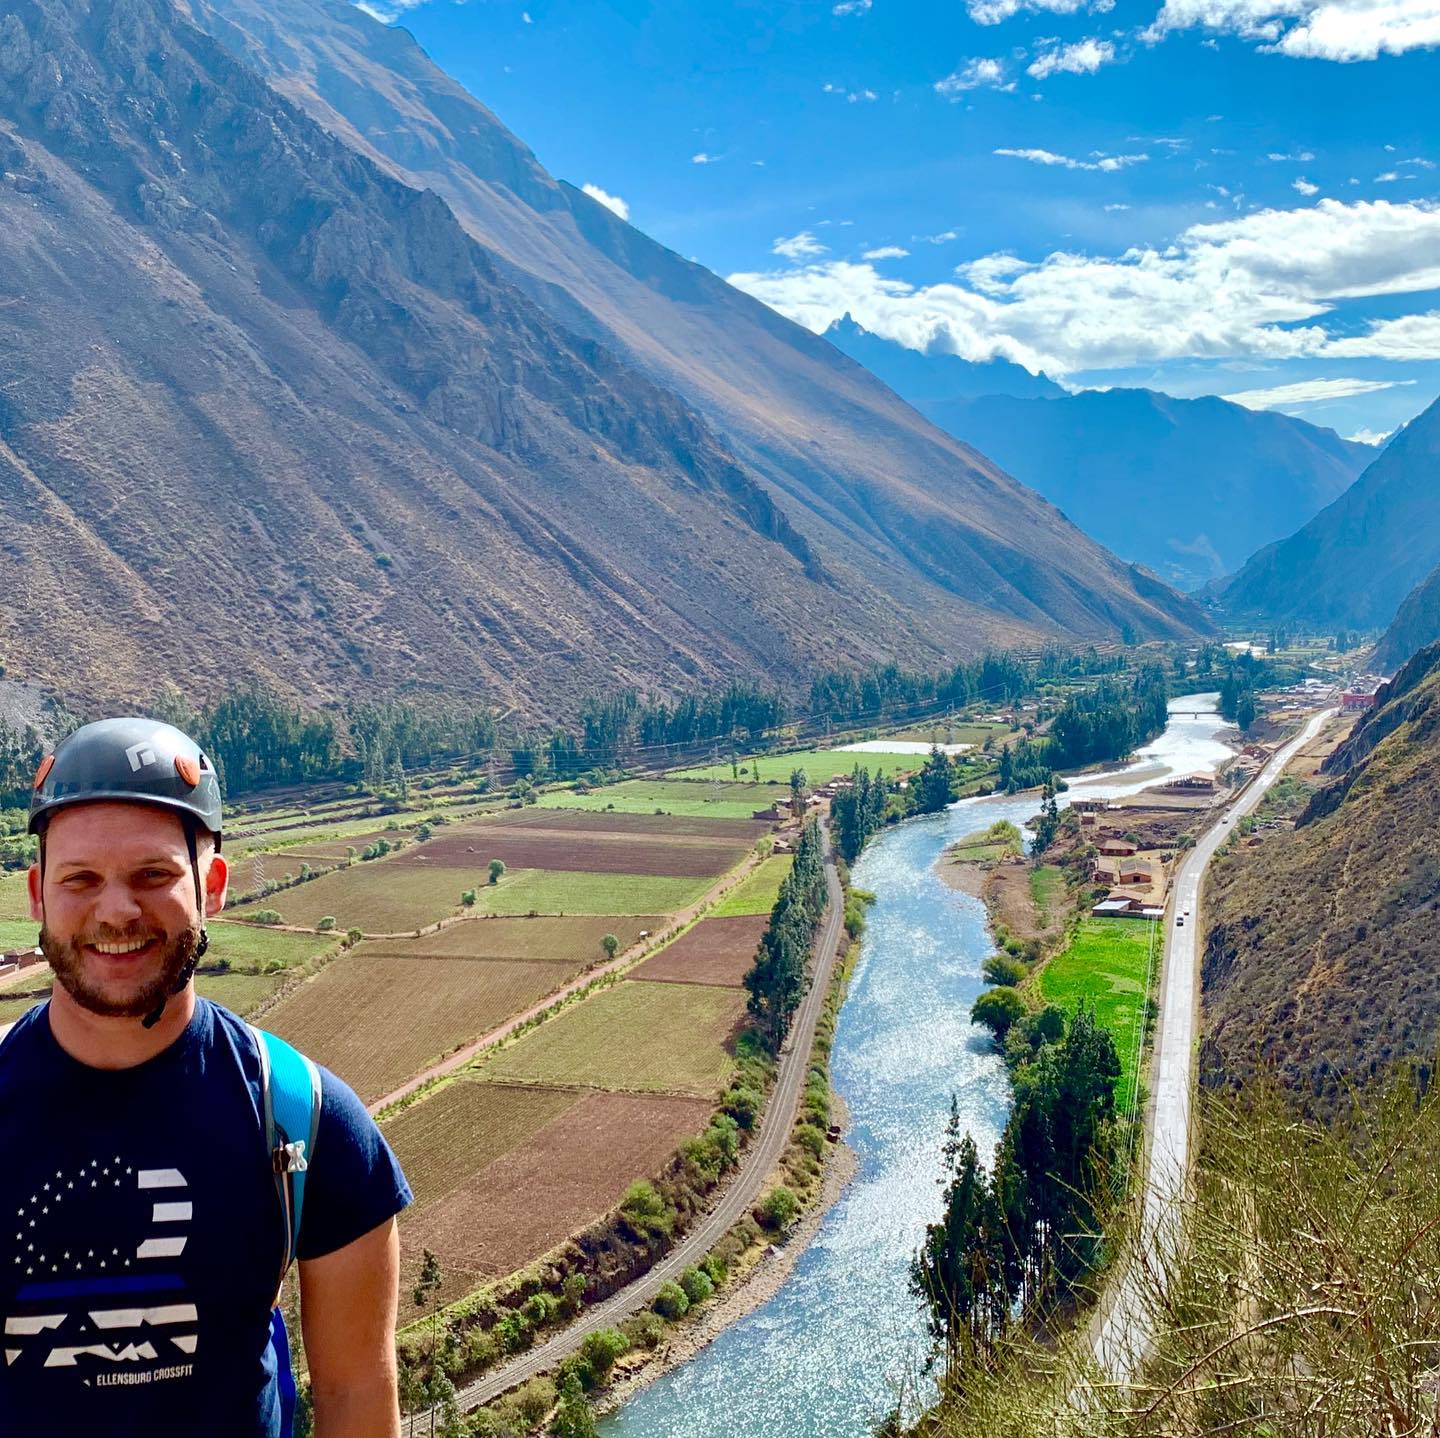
<box><xmin>400</xmin><ymin>1085</ymin><xmax>711</xmax><ymax>1301</ymax></box>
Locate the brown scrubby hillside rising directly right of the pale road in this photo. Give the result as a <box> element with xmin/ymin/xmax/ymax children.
<box><xmin>1201</xmin><ymin>643</ymin><xmax>1440</xmax><ymax>1113</ymax></box>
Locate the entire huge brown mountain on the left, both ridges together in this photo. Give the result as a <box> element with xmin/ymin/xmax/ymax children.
<box><xmin>0</xmin><ymin>0</ymin><xmax>1207</xmax><ymax>713</ymax></box>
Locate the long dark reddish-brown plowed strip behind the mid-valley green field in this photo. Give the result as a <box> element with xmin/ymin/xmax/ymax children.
<box><xmin>392</xmin><ymin>825</ymin><xmax>750</xmax><ymax>878</ymax></box>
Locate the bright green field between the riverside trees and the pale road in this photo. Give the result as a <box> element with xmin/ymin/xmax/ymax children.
<box><xmin>1040</xmin><ymin>918</ymin><xmax>1162</xmax><ymax>1111</ymax></box>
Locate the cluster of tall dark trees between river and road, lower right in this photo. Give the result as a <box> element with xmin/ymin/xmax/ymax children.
<box><xmin>910</xmin><ymin>1006</ymin><xmax>1120</xmax><ymax>1372</ymax></box>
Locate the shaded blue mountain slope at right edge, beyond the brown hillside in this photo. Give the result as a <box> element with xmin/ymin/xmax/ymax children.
<box><xmin>1212</xmin><ymin>400</ymin><xmax>1440</xmax><ymax>629</ymax></box>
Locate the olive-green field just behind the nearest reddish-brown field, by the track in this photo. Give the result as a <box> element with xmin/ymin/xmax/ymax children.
<box><xmin>481</xmin><ymin>983</ymin><xmax>744</xmax><ymax>1098</ymax></box>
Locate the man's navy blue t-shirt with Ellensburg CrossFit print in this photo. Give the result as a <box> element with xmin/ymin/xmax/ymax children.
<box><xmin>0</xmin><ymin>999</ymin><xmax>410</xmax><ymax>1438</ymax></box>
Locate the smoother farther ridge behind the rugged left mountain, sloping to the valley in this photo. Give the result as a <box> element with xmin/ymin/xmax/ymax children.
<box><xmin>177</xmin><ymin>0</ymin><xmax>1205</xmax><ymax>642</ymax></box>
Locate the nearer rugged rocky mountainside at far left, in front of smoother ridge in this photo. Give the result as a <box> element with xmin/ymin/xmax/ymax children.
<box><xmin>0</xmin><ymin>0</ymin><xmax>1185</xmax><ymax>711</ymax></box>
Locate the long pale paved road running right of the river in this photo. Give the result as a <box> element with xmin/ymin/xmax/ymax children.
<box><xmin>1093</xmin><ymin>710</ymin><xmax>1336</xmax><ymax>1383</ymax></box>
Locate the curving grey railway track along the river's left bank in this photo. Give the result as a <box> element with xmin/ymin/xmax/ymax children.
<box><xmin>417</xmin><ymin>826</ymin><xmax>845</xmax><ymax>1435</ymax></box>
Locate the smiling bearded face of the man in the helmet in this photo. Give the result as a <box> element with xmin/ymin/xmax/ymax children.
<box><xmin>30</xmin><ymin>803</ymin><xmax>225</xmax><ymax>1018</ymax></box>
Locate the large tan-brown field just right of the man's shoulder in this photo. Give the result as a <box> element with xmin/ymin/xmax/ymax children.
<box><xmin>265</xmin><ymin>951</ymin><xmax>583</xmax><ymax>1103</ymax></box>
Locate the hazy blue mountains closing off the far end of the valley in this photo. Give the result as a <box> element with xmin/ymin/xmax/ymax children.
<box><xmin>825</xmin><ymin>315</ymin><xmax>1375</xmax><ymax>589</ymax></box>
